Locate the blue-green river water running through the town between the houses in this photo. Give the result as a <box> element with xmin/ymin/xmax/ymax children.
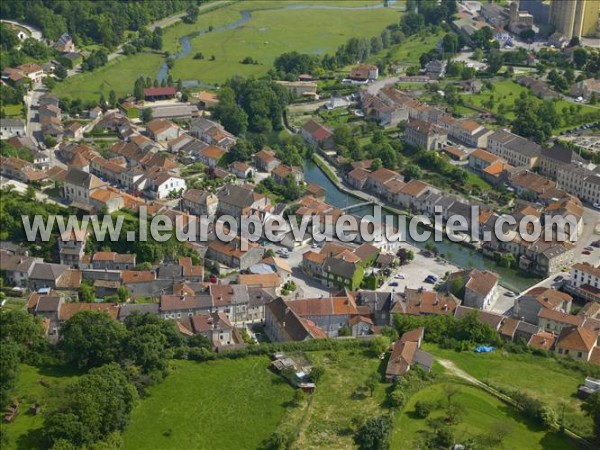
<box><xmin>304</xmin><ymin>160</ymin><xmax>541</xmax><ymax>292</ymax></box>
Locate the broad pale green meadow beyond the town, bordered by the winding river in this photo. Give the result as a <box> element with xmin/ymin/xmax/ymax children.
<box><xmin>171</xmin><ymin>0</ymin><xmax>401</xmax><ymax>83</ymax></box>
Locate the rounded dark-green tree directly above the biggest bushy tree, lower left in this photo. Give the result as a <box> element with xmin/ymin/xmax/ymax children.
<box><xmin>59</xmin><ymin>311</ymin><xmax>126</xmax><ymax>367</ymax></box>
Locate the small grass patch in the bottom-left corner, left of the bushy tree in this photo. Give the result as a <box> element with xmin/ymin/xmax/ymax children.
<box><xmin>1</xmin><ymin>364</ymin><xmax>81</xmax><ymax>449</ymax></box>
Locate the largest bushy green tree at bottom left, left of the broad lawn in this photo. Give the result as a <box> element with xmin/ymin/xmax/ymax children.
<box><xmin>44</xmin><ymin>364</ymin><xmax>138</xmax><ymax>447</ymax></box>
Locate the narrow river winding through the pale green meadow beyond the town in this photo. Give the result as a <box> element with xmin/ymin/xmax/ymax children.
<box><xmin>156</xmin><ymin>0</ymin><xmax>404</xmax><ymax>82</ymax></box>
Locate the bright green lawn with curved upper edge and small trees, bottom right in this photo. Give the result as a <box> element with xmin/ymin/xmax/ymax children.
<box><xmin>391</xmin><ymin>383</ymin><xmax>575</xmax><ymax>450</ymax></box>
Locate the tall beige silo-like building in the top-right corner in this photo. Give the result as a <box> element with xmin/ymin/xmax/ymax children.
<box><xmin>550</xmin><ymin>0</ymin><xmax>600</xmax><ymax>39</ymax></box>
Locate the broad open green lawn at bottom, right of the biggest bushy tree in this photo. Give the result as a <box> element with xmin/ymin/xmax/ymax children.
<box><xmin>124</xmin><ymin>357</ymin><xmax>293</xmax><ymax>450</ymax></box>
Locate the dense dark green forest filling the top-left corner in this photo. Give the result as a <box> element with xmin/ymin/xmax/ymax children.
<box><xmin>0</xmin><ymin>0</ymin><xmax>203</xmax><ymax>49</ymax></box>
